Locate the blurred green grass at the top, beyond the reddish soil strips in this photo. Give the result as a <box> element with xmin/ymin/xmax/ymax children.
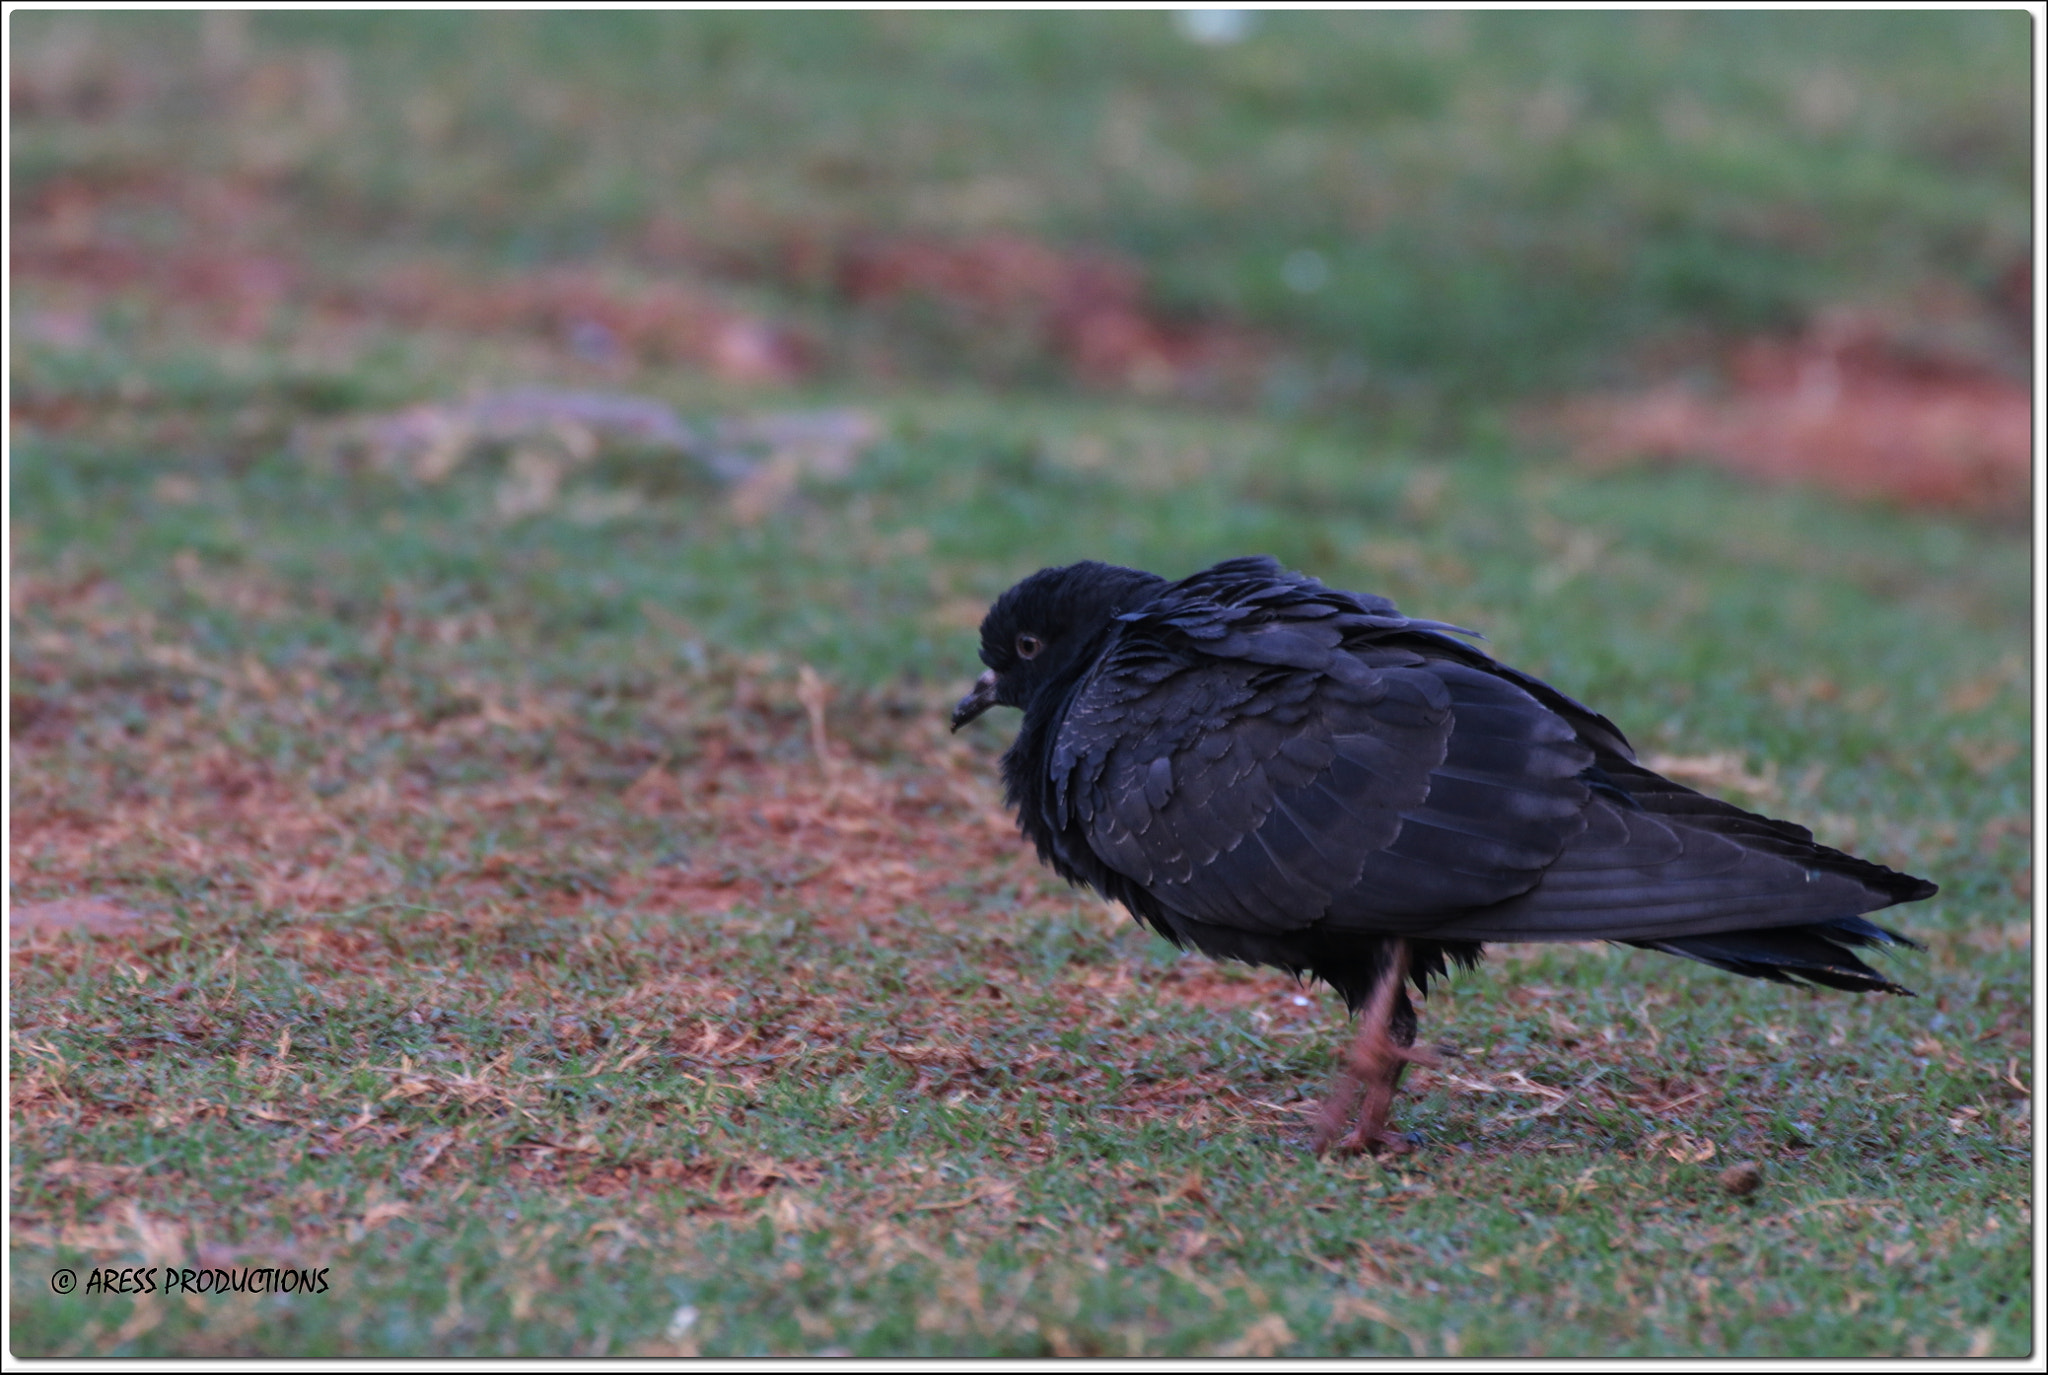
<box><xmin>12</xmin><ymin>12</ymin><xmax>2032</xmax><ymax>405</ymax></box>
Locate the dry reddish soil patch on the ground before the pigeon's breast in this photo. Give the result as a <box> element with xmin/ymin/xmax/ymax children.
<box><xmin>8</xmin><ymin>582</ymin><xmax>1307</xmax><ymax>1012</ymax></box>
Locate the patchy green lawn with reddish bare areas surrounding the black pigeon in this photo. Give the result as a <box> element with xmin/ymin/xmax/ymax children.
<box><xmin>8</xmin><ymin>14</ymin><xmax>2036</xmax><ymax>1359</ymax></box>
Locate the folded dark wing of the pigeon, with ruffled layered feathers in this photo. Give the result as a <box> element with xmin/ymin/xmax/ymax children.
<box><xmin>1047</xmin><ymin>561</ymin><xmax>1591</xmax><ymax>932</ymax></box>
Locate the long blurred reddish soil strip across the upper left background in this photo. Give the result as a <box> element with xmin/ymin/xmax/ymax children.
<box><xmin>10</xmin><ymin>176</ymin><xmax>1274</xmax><ymax>395</ymax></box>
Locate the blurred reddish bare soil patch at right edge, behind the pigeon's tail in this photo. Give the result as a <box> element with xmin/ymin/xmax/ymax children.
<box><xmin>1542</xmin><ymin>314</ymin><xmax>2034</xmax><ymax>514</ymax></box>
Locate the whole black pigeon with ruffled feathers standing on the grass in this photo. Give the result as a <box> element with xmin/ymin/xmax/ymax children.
<box><xmin>952</xmin><ymin>557</ymin><xmax>1935</xmax><ymax>1152</ymax></box>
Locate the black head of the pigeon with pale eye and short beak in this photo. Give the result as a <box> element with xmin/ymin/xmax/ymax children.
<box><xmin>952</xmin><ymin>564</ymin><xmax>1165</xmax><ymax>730</ymax></box>
